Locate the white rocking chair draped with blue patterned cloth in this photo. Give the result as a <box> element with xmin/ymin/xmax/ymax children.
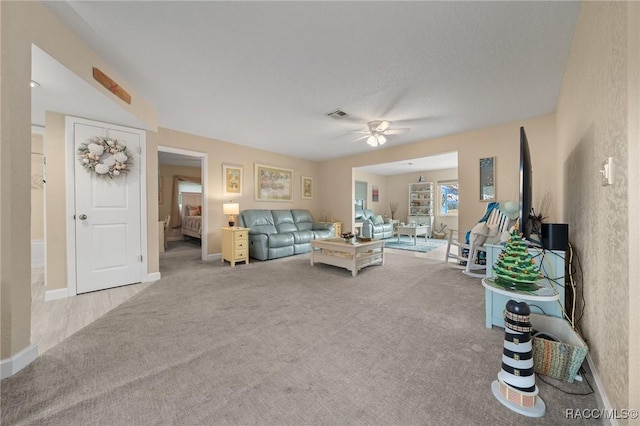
<box><xmin>445</xmin><ymin>202</ymin><xmax>517</xmax><ymax>278</ymax></box>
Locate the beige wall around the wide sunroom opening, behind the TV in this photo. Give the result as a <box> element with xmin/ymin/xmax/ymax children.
<box><xmin>320</xmin><ymin>115</ymin><xmax>560</xmax><ymax>236</ymax></box>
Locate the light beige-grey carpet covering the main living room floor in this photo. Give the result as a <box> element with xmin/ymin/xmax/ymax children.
<box><xmin>1</xmin><ymin>251</ymin><xmax>597</xmax><ymax>425</ymax></box>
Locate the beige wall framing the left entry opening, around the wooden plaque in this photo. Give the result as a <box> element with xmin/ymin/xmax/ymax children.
<box><xmin>0</xmin><ymin>1</ymin><xmax>157</xmax><ymax>359</ymax></box>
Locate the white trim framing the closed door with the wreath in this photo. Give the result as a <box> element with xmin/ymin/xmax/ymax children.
<box><xmin>65</xmin><ymin>115</ymin><xmax>150</xmax><ymax>296</ymax></box>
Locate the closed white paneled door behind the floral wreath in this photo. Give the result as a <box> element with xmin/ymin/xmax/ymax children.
<box><xmin>73</xmin><ymin>120</ymin><xmax>144</xmax><ymax>293</ymax></box>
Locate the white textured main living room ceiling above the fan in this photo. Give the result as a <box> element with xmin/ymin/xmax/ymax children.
<box><xmin>38</xmin><ymin>1</ymin><xmax>580</xmax><ymax>166</ymax></box>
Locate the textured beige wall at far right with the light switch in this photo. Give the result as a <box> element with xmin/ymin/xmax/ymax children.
<box><xmin>556</xmin><ymin>2</ymin><xmax>640</xmax><ymax>409</ymax></box>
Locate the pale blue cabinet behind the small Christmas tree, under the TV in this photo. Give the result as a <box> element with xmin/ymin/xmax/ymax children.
<box><xmin>484</xmin><ymin>244</ymin><xmax>565</xmax><ymax>328</ymax></box>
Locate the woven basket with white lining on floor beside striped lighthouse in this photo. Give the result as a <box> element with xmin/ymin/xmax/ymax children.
<box><xmin>530</xmin><ymin>314</ymin><xmax>588</xmax><ymax>383</ymax></box>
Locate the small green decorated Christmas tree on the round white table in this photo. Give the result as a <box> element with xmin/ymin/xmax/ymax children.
<box><xmin>493</xmin><ymin>229</ymin><xmax>542</xmax><ymax>290</ymax></box>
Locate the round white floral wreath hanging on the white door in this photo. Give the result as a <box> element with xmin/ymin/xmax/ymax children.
<box><xmin>78</xmin><ymin>136</ymin><xmax>133</xmax><ymax>179</ymax></box>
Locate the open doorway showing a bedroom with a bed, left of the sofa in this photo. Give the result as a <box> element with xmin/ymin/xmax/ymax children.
<box><xmin>158</xmin><ymin>147</ymin><xmax>208</xmax><ymax>266</ymax></box>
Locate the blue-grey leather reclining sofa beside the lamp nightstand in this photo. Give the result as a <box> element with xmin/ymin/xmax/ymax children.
<box><xmin>238</xmin><ymin>209</ymin><xmax>334</xmax><ymax>260</ymax></box>
